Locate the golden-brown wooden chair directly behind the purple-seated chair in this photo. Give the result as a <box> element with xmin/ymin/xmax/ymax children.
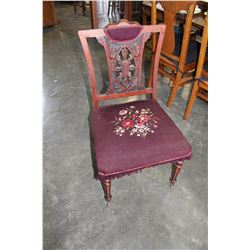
<box><xmin>152</xmin><ymin>1</ymin><xmax>200</xmax><ymax>107</ymax></box>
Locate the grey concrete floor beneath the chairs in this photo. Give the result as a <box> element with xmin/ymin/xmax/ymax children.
<box><xmin>43</xmin><ymin>4</ymin><xmax>208</xmax><ymax>250</ymax></box>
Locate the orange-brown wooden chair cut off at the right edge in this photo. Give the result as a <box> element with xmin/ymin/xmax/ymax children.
<box><xmin>183</xmin><ymin>16</ymin><xmax>208</xmax><ymax>120</ymax></box>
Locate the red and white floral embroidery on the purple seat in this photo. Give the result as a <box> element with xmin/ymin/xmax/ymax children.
<box><xmin>113</xmin><ymin>106</ymin><xmax>160</xmax><ymax>138</ymax></box>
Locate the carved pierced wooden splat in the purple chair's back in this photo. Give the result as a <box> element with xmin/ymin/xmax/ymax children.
<box><xmin>98</xmin><ymin>27</ymin><xmax>150</xmax><ymax>94</ymax></box>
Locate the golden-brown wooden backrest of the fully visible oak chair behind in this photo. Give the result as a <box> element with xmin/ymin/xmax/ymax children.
<box><xmin>159</xmin><ymin>1</ymin><xmax>196</xmax><ymax>64</ymax></box>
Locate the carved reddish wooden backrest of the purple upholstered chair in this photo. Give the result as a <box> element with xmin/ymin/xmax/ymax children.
<box><xmin>78</xmin><ymin>20</ymin><xmax>165</xmax><ymax>109</ymax></box>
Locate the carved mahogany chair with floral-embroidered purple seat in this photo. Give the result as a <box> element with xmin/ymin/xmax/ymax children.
<box><xmin>79</xmin><ymin>20</ymin><xmax>192</xmax><ymax>204</ymax></box>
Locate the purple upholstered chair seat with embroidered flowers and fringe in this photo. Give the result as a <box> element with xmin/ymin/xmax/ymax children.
<box><xmin>92</xmin><ymin>100</ymin><xmax>192</xmax><ymax>180</ymax></box>
